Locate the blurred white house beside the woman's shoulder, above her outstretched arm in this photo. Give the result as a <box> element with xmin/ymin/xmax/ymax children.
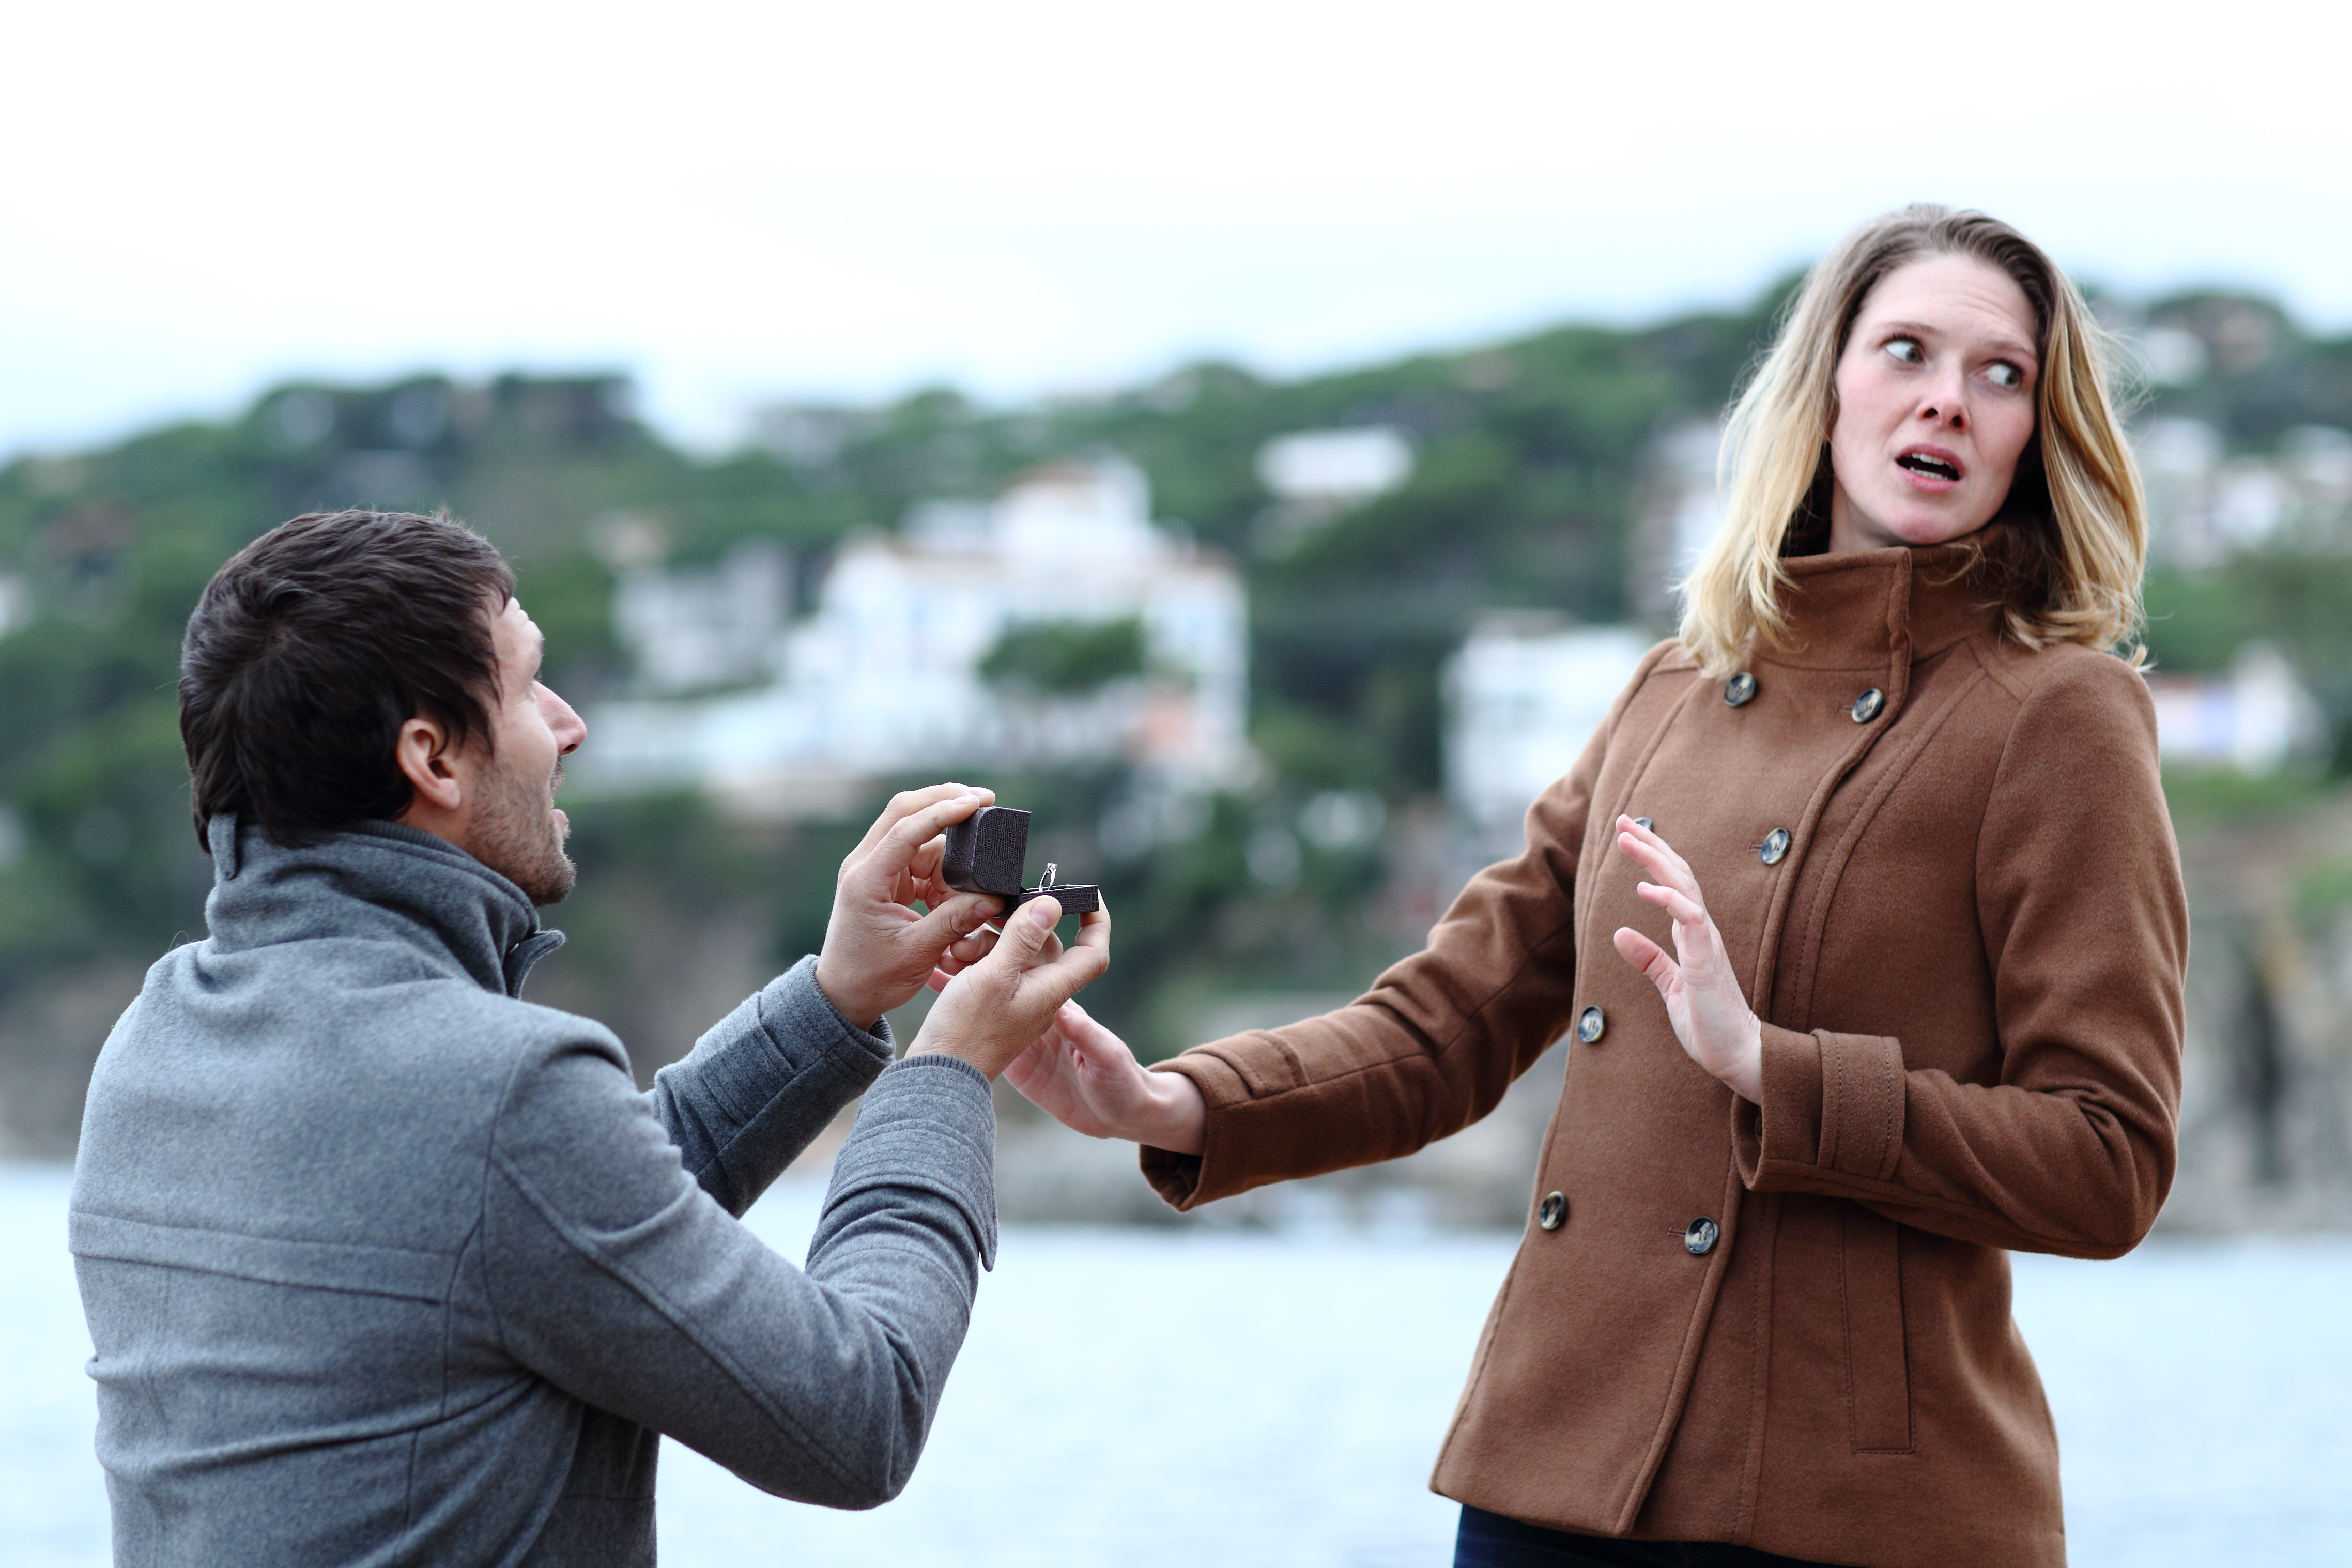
<box><xmin>1444</xmin><ymin>611</ymin><xmax>1653</xmax><ymax>863</ymax></box>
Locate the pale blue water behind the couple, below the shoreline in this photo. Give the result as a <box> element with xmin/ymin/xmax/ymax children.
<box><xmin>13</xmin><ymin>1166</ymin><xmax>2352</xmax><ymax>1568</ymax></box>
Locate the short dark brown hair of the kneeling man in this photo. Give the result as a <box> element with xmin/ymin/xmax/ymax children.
<box><xmin>179</xmin><ymin>513</ymin><xmax>515</xmax><ymax>844</ymax></box>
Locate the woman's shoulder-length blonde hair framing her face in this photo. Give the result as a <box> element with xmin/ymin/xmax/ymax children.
<box><xmin>1682</xmin><ymin>202</ymin><xmax>2147</xmax><ymax>674</ymax></box>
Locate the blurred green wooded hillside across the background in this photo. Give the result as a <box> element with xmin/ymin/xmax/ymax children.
<box><xmin>0</xmin><ymin>294</ymin><xmax>2352</xmax><ymax>1241</ymax></box>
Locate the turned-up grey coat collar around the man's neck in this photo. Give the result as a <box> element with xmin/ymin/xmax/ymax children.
<box><xmin>205</xmin><ymin>816</ymin><xmax>564</xmax><ymax>997</ymax></box>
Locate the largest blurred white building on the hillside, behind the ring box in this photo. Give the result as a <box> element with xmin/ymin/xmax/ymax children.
<box><xmin>579</xmin><ymin>458</ymin><xmax>1249</xmax><ymax>818</ymax></box>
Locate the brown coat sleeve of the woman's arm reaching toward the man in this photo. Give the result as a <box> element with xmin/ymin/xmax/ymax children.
<box><xmin>1143</xmin><ymin>644</ymin><xmax>1674</xmax><ymax>1208</ymax></box>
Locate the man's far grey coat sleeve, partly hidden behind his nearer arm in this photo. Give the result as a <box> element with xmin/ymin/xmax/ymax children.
<box><xmin>647</xmin><ymin>957</ymin><xmax>896</xmax><ymax>1216</ymax></box>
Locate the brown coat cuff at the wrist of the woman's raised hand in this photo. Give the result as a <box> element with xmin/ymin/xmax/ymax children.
<box><xmin>1731</xmin><ymin>1023</ymin><xmax>1903</xmax><ymax>1190</ymax></box>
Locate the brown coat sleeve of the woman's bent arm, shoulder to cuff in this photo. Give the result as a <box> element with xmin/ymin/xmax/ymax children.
<box><xmin>1733</xmin><ymin>658</ymin><xmax>2190</xmax><ymax>1258</ymax></box>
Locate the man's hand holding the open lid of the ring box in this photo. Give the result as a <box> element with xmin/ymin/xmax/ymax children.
<box><xmin>816</xmin><ymin>785</ymin><xmax>1006</xmax><ymax>1029</ymax></box>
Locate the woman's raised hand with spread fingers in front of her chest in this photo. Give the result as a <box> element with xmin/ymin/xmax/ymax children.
<box><xmin>1618</xmin><ymin>816</ymin><xmax>1764</xmax><ymax>1105</ymax></box>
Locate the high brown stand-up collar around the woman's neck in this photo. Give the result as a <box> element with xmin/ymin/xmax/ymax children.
<box><xmin>1757</xmin><ymin>545</ymin><xmax>2002</xmax><ymax>670</ymax></box>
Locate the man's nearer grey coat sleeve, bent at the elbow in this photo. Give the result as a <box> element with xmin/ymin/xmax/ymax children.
<box><xmin>480</xmin><ymin>1041</ymin><xmax>995</xmax><ymax>1507</ymax></box>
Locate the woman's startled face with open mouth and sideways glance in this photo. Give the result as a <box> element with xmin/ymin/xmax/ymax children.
<box><xmin>1830</xmin><ymin>256</ymin><xmax>2041</xmax><ymax>550</ymax></box>
